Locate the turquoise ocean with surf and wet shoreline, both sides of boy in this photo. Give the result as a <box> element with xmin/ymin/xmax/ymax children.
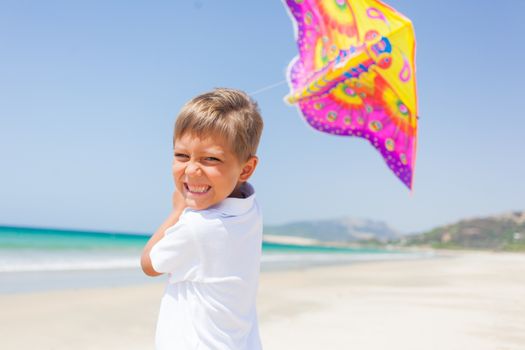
<box><xmin>0</xmin><ymin>226</ymin><xmax>425</xmax><ymax>293</ymax></box>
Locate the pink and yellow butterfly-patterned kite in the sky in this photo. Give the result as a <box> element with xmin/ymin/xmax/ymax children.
<box><xmin>286</xmin><ymin>0</ymin><xmax>418</xmax><ymax>189</ymax></box>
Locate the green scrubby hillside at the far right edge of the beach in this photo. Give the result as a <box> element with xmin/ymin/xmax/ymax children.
<box><xmin>400</xmin><ymin>211</ymin><xmax>525</xmax><ymax>251</ymax></box>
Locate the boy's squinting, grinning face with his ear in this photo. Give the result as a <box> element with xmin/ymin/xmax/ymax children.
<box><xmin>172</xmin><ymin>133</ymin><xmax>257</xmax><ymax>210</ymax></box>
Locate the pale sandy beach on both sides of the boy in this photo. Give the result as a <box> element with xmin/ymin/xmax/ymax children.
<box><xmin>0</xmin><ymin>252</ymin><xmax>525</xmax><ymax>350</ymax></box>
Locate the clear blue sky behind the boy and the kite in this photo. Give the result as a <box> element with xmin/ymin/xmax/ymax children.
<box><xmin>0</xmin><ymin>0</ymin><xmax>525</xmax><ymax>233</ymax></box>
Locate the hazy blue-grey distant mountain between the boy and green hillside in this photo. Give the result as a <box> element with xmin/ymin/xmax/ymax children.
<box><xmin>264</xmin><ymin>218</ymin><xmax>401</xmax><ymax>244</ymax></box>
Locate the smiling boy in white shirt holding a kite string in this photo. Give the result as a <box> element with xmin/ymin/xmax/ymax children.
<box><xmin>141</xmin><ymin>89</ymin><xmax>263</xmax><ymax>350</ymax></box>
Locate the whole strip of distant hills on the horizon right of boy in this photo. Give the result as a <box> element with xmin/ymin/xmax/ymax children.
<box><xmin>264</xmin><ymin>212</ymin><xmax>525</xmax><ymax>252</ymax></box>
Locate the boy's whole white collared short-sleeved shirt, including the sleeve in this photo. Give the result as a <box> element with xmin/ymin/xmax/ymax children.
<box><xmin>150</xmin><ymin>184</ymin><xmax>262</xmax><ymax>350</ymax></box>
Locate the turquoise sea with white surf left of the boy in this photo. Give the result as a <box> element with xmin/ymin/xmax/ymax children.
<box><xmin>0</xmin><ymin>226</ymin><xmax>149</xmax><ymax>272</ymax></box>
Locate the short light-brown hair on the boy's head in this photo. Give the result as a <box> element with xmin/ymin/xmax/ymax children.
<box><xmin>173</xmin><ymin>88</ymin><xmax>263</xmax><ymax>161</ymax></box>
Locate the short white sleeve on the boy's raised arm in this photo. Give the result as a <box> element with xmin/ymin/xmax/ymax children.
<box><xmin>150</xmin><ymin>215</ymin><xmax>203</xmax><ymax>282</ymax></box>
